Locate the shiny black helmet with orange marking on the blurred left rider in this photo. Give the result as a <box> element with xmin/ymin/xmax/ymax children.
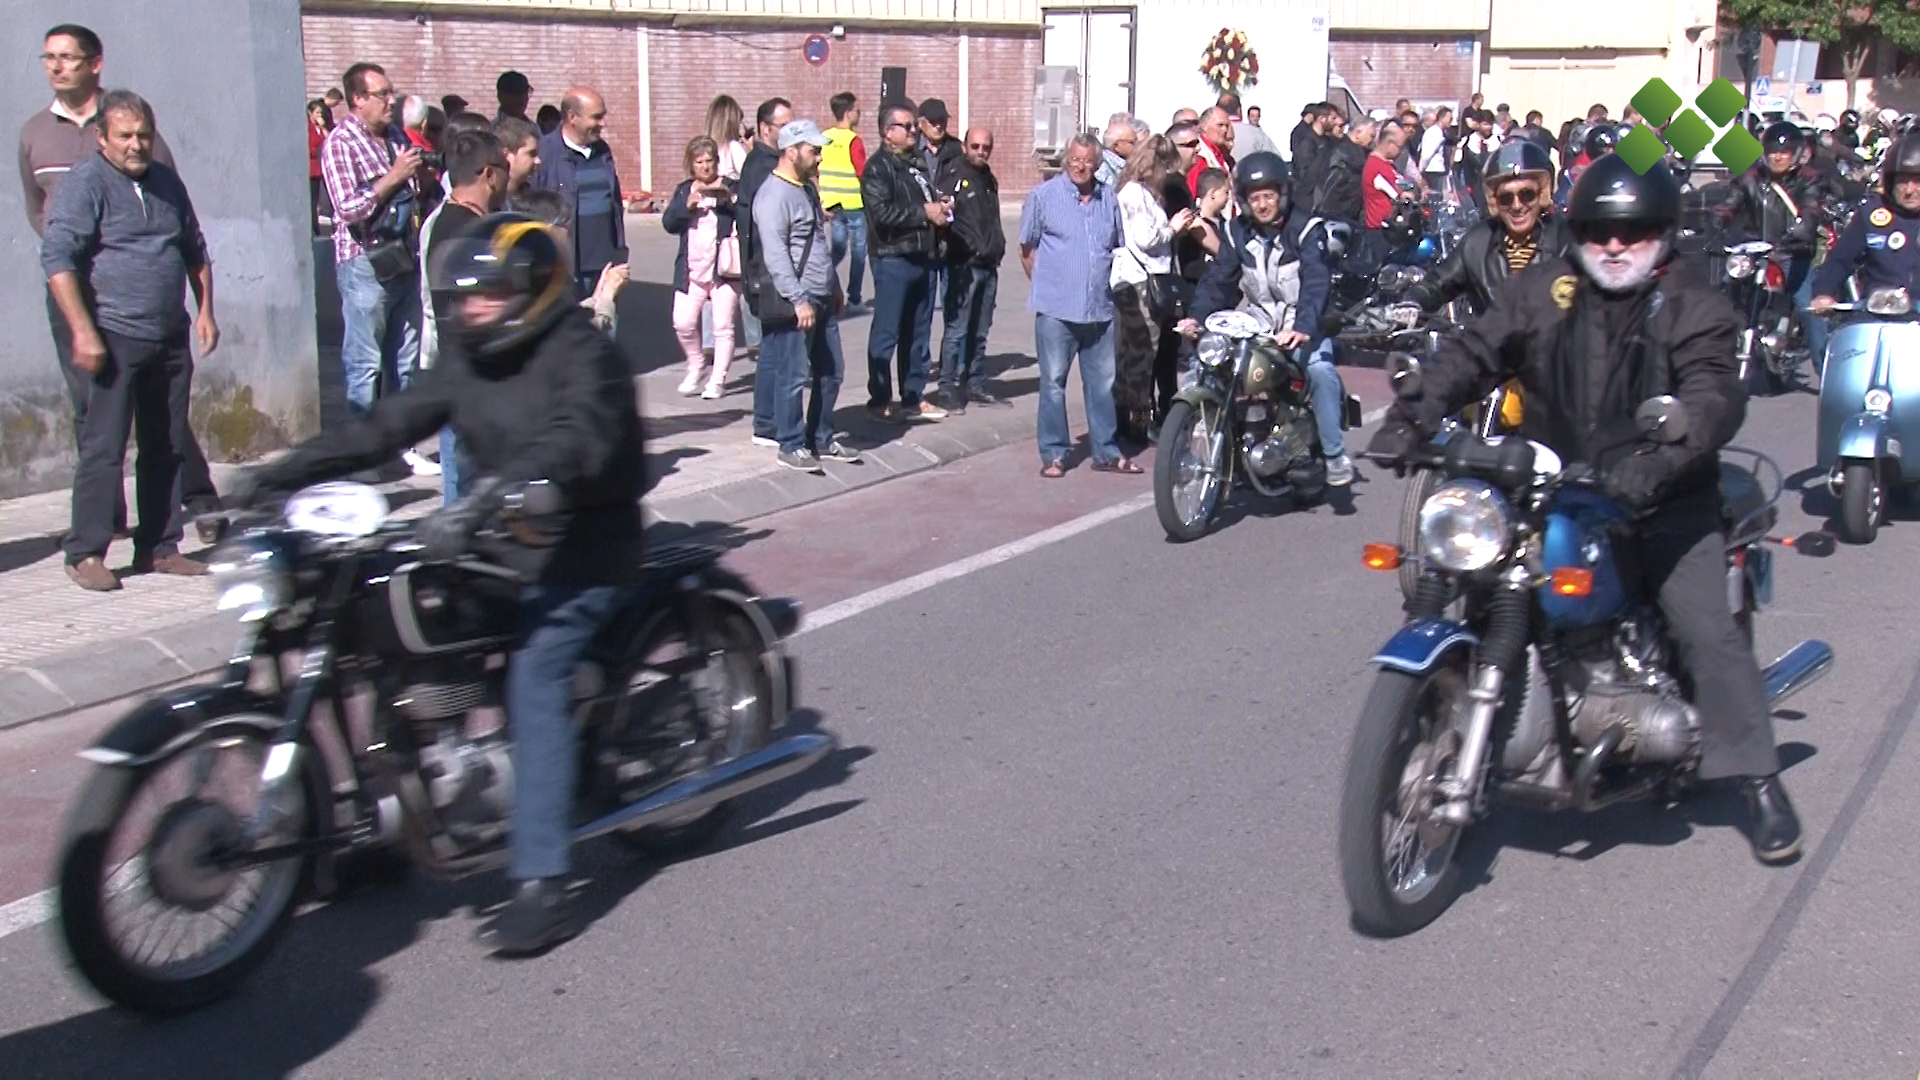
<box><xmin>432</xmin><ymin>213</ymin><xmax>574</xmax><ymax>361</ymax></box>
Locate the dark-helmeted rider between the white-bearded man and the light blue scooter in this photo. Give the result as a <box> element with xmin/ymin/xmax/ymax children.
<box><xmin>1718</xmin><ymin>121</ymin><xmax>1845</xmax><ymax>363</ymax></box>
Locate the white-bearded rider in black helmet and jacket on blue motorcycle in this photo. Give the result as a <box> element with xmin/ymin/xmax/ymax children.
<box><xmin>1367</xmin><ymin>154</ymin><xmax>1801</xmax><ymax>863</ymax></box>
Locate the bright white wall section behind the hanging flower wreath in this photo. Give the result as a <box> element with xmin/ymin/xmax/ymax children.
<box><xmin>1135</xmin><ymin>0</ymin><xmax>1331</xmax><ymax>136</ymax></box>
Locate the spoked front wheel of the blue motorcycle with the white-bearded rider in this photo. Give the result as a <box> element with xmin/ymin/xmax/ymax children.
<box><xmin>1340</xmin><ymin>667</ymin><xmax>1469</xmax><ymax>938</ymax></box>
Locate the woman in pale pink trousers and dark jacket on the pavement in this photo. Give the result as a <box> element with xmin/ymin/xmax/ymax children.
<box><xmin>660</xmin><ymin>135</ymin><xmax>741</xmax><ymax>402</ymax></box>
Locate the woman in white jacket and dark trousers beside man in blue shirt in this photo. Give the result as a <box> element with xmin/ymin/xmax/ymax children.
<box><xmin>1108</xmin><ymin>135</ymin><xmax>1198</xmax><ymax>442</ymax></box>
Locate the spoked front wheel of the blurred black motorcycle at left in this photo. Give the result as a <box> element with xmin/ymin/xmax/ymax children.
<box><xmin>60</xmin><ymin>730</ymin><xmax>309</xmax><ymax>1015</ymax></box>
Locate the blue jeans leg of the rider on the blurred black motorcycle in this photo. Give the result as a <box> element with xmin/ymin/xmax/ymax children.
<box><xmin>507</xmin><ymin>584</ymin><xmax>632</xmax><ymax>880</ymax></box>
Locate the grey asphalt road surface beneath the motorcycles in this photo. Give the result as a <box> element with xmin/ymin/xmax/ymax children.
<box><xmin>0</xmin><ymin>384</ymin><xmax>1920</xmax><ymax>1080</ymax></box>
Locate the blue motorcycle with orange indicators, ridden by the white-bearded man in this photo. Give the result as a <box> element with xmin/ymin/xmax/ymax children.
<box><xmin>1338</xmin><ymin>390</ymin><xmax>1834</xmax><ymax>936</ymax></box>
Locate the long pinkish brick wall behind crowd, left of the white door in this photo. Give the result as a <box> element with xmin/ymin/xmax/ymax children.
<box><xmin>301</xmin><ymin>12</ymin><xmax>1041</xmax><ymax>198</ymax></box>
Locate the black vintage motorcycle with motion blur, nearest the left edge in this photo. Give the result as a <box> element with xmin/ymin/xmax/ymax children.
<box><xmin>58</xmin><ymin>482</ymin><xmax>833</xmax><ymax>1015</ymax></box>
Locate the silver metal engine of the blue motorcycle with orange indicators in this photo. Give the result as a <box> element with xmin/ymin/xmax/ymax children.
<box><xmin>1569</xmin><ymin>619</ymin><xmax>1699</xmax><ymax>765</ymax></box>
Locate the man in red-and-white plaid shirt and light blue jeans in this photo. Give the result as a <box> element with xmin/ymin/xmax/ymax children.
<box><xmin>321</xmin><ymin>63</ymin><xmax>420</xmax><ymax>419</ymax></box>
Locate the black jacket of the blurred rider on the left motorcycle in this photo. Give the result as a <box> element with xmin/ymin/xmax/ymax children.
<box><xmin>261</xmin><ymin>300</ymin><xmax>647</xmax><ymax>586</ymax></box>
